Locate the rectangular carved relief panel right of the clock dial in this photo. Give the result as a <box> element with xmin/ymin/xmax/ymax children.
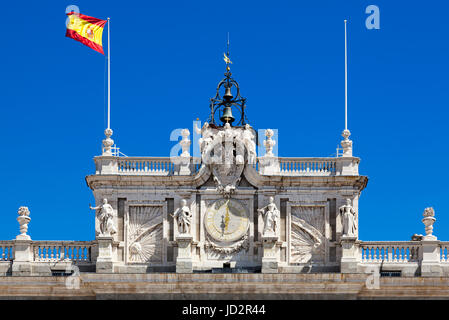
<box><xmin>291</xmin><ymin>206</ymin><xmax>326</xmax><ymax>263</ymax></box>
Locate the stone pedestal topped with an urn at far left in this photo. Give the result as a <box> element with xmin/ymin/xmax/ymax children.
<box><xmin>12</xmin><ymin>207</ymin><xmax>33</xmax><ymax>276</ymax></box>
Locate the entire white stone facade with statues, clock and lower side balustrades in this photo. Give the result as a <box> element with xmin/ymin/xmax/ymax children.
<box><xmin>0</xmin><ymin>125</ymin><xmax>449</xmax><ymax>277</ymax></box>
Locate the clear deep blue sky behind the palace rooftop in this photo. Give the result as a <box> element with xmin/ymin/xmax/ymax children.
<box><xmin>0</xmin><ymin>0</ymin><xmax>449</xmax><ymax>240</ymax></box>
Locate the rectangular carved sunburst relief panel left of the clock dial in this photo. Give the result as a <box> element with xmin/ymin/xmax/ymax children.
<box><xmin>128</xmin><ymin>206</ymin><xmax>162</xmax><ymax>263</ymax></box>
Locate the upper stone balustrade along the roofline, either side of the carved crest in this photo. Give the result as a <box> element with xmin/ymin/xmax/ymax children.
<box><xmin>95</xmin><ymin>156</ymin><xmax>359</xmax><ymax>176</ymax></box>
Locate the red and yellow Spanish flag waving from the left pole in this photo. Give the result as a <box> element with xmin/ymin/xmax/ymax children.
<box><xmin>65</xmin><ymin>12</ymin><xmax>107</xmax><ymax>54</ymax></box>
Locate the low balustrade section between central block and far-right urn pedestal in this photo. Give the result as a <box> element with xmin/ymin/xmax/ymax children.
<box><xmin>360</xmin><ymin>241</ymin><xmax>421</xmax><ymax>263</ymax></box>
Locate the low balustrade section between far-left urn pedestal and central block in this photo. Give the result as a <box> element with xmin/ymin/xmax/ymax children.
<box><xmin>32</xmin><ymin>241</ymin><xmax>95</xmax><ymax>263</ymax></box>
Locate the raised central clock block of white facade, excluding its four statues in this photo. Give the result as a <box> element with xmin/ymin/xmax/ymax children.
<box><xmin>86</xmin><ymin>124</ymin><xmax>367</xmax><ymax>272</ymax></box>
